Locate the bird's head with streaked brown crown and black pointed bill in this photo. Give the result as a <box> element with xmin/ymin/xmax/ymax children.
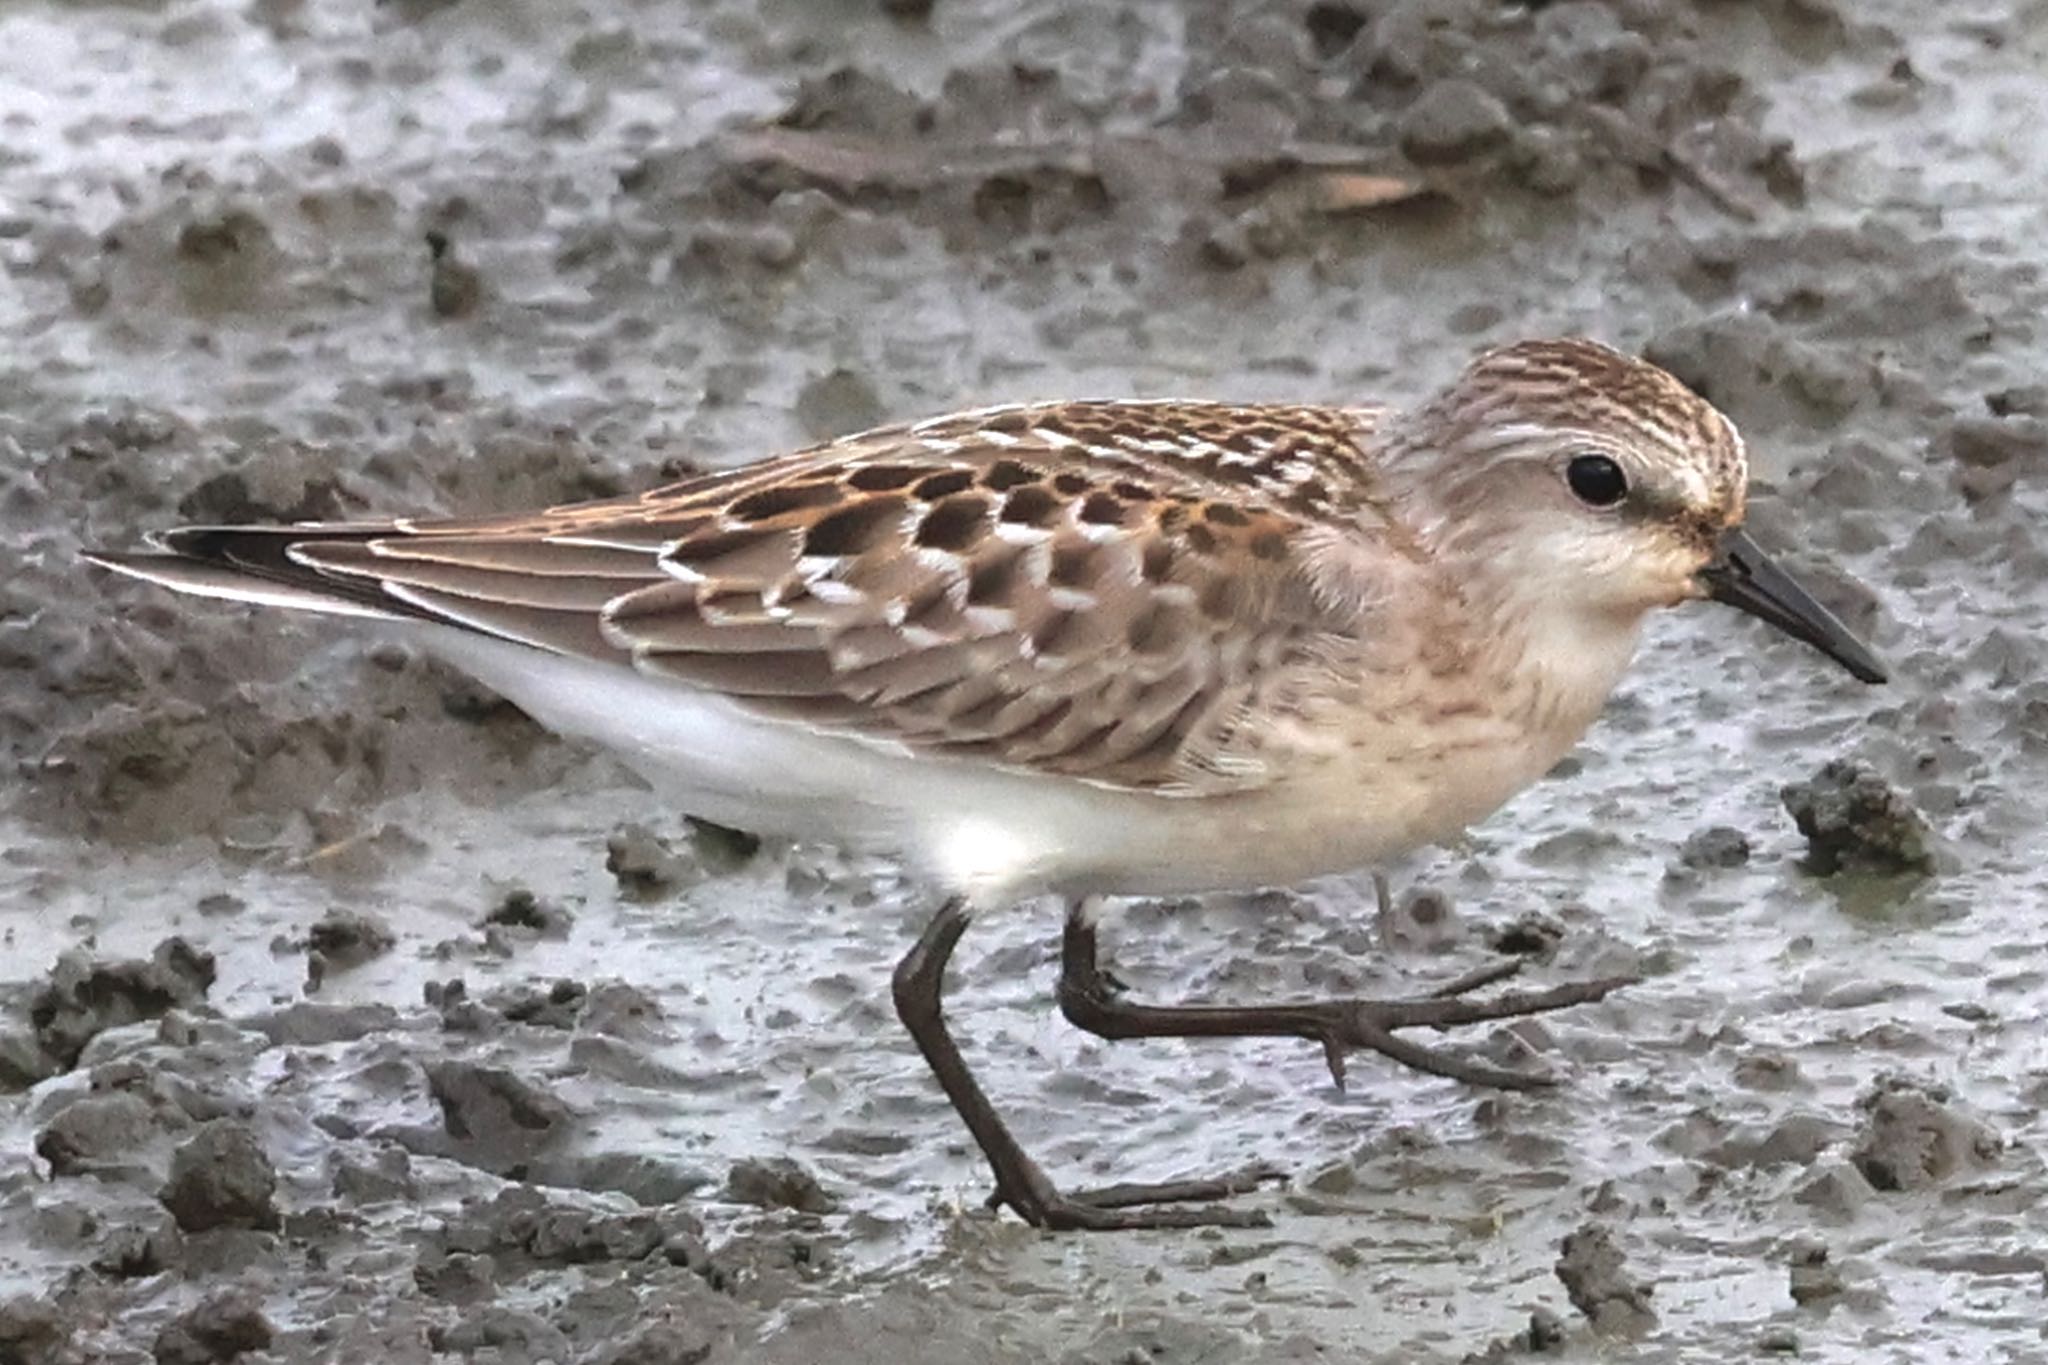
<box><xmin>1386</xmin><ymin>340</ymin><xmax>1886</xmax><ymax>684</ymax></box>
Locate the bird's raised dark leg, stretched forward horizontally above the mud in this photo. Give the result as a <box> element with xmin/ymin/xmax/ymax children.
<box><xmin>1059</xmin><ymin>905</ymin><xmax>1636</xmax><ymax>1091</ymax></box>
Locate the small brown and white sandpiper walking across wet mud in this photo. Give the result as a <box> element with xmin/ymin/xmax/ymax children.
<box><xmin>90</xmin><ymin>340</ymin><xmax>1884</xmax><ymax>1228</ymax></box>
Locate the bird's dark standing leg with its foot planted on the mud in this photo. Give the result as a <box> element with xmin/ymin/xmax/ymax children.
<box><xmin>891</xmin><ymin>898</ymin><xmax>1272</xmax><ymax>1230</ymax></box>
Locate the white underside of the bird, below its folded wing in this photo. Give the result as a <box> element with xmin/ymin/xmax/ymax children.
<box><xmin>418</xmin><ymin>628</ymin><xmax>1548</xmax><ymax>905</ymax></box>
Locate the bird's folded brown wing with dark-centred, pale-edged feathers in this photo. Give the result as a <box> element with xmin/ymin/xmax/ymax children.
<box><xmin>102</xmin><ymin>409</ymin><xmax>1356</xmax><ymax>794</ymax></box>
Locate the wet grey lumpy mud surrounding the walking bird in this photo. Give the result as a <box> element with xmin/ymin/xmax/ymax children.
<box><xmin>0</xmin><ymin>0</ymin><xmax>2048</xmax><ymax>1361</ymax></box>
